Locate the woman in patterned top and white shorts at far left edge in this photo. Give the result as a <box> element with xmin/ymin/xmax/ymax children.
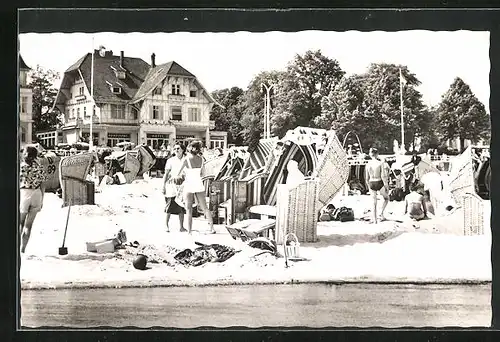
<box><xmin>19</xmin><ymin>146</ymin><xmax>47</xmax><ymax>253</ymax></box>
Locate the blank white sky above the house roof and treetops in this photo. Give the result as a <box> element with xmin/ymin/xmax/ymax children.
<box><xmin>19</xmin><ymin>30</ymin><xmax>490</xmax><ymax>111</ymax></box>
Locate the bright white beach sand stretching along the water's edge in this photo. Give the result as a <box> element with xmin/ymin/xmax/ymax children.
<box><xmin>21</xmin><ymin>179</ymin><xmax>491</xmax><ymax>288</ymax></box>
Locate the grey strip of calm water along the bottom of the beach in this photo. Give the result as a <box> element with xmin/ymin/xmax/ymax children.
<box><xmin>21</xmin><ymin>284</ymin><xmax>491</xmax><ymax>328</ymax></box>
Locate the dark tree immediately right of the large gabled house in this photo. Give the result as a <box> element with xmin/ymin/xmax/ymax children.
<box><xmin>210</xmin><ymin>87</ymin><xmax>243</xmax><ymax>145</ymax></box>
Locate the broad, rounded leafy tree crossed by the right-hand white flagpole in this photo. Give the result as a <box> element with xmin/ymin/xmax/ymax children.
<box><xmin>314</xmin><ymin>63</ymin><xmax>432</xmax><ymax>151</ymax></box>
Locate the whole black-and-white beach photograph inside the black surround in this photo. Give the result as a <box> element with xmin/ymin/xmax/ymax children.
<box><xmin>18</xmin><ymin>9</ymin><xmax>492</xmax><ymax>330</ymax></box>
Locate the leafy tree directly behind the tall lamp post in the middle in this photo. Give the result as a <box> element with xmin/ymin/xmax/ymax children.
<box><xmin>239</xmin><ymin>71</ymin><xmax>282</xmax><ymax>149</ymax></box>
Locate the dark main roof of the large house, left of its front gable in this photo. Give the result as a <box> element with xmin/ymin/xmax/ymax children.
<box><xmin>56</xmin><ymin>50</ymin><xmax>150</xmax><ymax>104</ymax></box>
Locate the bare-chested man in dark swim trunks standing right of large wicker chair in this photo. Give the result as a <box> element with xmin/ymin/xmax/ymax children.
<box><xmin>365</xmin><ymin>147</ymin><xmax>389</xmax><ymax>223</ymax></box>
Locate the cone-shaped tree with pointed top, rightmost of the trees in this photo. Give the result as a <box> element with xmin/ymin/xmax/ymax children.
<box><xmin>438</xmin><ymin>77</ymin><xmax>491</xmax><ymax>149</ymax></box>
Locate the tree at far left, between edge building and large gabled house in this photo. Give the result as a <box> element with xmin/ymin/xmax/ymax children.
<box><xmin>28</xmin><ymin>65</ymin><xmax>61</xmax><ymax>138</ymax></box>
